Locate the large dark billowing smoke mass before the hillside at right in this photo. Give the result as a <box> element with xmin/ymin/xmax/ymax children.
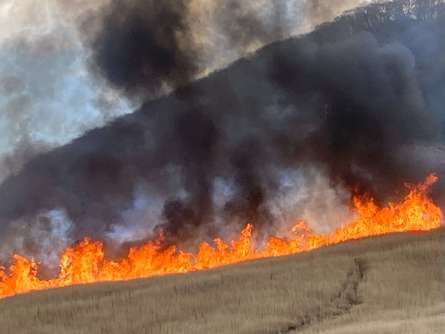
<box><xmin>272</xmin><ymin>33</ymin><xmax>441</xmax><ymax>196</ymax></box>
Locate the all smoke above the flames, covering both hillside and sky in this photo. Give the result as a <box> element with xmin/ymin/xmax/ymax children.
<box><xmin>0</xmin><ymin>0</ymin><xmax>445</xmax><ymax>268</ymax></box>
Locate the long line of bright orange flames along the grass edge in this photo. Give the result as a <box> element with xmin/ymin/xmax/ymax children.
<box><xmin>0</xmin><ymin>175</ymin><xmax>443</xmax><ymax>298</ymax></box>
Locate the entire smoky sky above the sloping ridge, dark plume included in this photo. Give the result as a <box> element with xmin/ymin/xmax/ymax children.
<box><xmin>0</xmin><ymin>0</ymin><xmax>368</xmax><ymax>187</ymax></box>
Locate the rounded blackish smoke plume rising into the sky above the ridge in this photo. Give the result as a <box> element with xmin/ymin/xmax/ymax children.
<box><xmin>93</xmin><ymin>0</ymin><xmax>198</xmax><ymax>95</ymax></box>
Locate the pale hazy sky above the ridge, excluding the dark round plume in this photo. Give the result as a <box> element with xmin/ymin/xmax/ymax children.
<box><xmin>0</xmin><ymin>0</ymin><xmax>370</xmax><ymax>180</ymax></box>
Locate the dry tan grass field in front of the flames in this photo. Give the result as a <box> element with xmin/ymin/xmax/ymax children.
<box><xmin>0</xmin><ymin>229</ymin><xmax>445</xmax><ymax>334</ymax></box>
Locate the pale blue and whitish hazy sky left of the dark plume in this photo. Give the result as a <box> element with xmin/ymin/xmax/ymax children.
<box><xmin>0</xmin><ymin>0</ymin><xmax>129</xmax><ymax>181</ymax></box>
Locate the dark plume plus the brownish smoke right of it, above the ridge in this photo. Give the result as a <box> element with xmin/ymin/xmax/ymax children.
<box><xmin>90</xmin><ymin>0</ymin><xmax>372</xmax><ymax>99</ymax></box>
